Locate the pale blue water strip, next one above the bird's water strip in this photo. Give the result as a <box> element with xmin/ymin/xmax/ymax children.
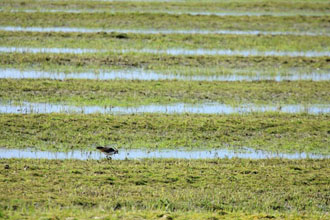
<box><xmin>0</xmin><ymin>102</ymin><xmax>330</xmax><ymax>114</ymax></box>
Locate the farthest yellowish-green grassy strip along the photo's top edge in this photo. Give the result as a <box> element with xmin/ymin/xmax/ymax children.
<box><xmin>0</xmin><ymin>0</ymin><xmax>329</xmax><ymax>13</ymax></box>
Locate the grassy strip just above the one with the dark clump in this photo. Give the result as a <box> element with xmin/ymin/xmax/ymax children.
<box><xmin>0</xmin><ymin>12</ymin><xmax>330</xmax><ymax>32</ymax></box>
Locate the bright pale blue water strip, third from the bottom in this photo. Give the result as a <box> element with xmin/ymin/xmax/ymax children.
<box><xmin>0</xmin><ymin>69</ymin><xmax>330</xmax><ymax>81</ymax></box>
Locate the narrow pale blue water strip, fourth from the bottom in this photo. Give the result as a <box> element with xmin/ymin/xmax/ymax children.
<box><xmin>0</xmin><ymin>47</ymin><xmax>330</xmax><ymax>57</ymax></box>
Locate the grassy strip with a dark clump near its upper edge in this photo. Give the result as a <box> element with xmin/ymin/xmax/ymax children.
<box><xmin>0</xmin><ymin>31</ymin><xmax>330</xmax><ymax>51</ymax></box>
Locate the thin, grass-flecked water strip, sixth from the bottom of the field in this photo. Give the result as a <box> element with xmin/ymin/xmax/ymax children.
<box><xmin>0</xmin><ymin>8</ymin><xmax>327</xmax><ymax>17</ymax></box>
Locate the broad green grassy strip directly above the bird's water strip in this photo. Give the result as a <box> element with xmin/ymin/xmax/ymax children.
<box><xmin>0</xmin><ymin>114</ymin><xmax>330</xmax><ymax>154</ymax></box>
